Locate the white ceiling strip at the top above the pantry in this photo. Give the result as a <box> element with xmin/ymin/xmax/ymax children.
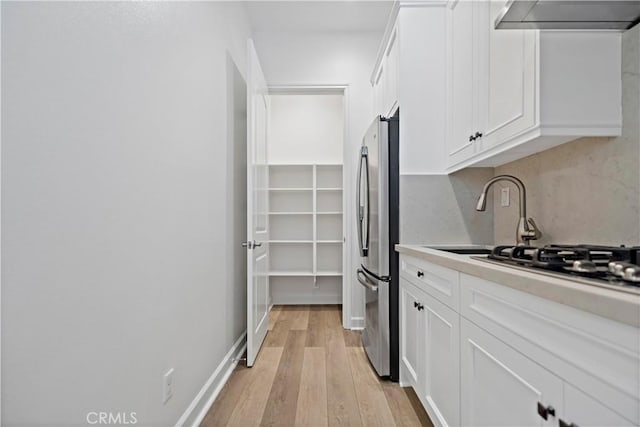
<box><xmin>247</xmin><ymin>0</ymin><xmax>393</xmax><ymax>32</ymax></box>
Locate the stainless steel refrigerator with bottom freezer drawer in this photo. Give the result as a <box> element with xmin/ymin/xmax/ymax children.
<box><xmin>356</xmin><ymin>113</ymin><xmax>399</xmax><ymax>381</ymax></box>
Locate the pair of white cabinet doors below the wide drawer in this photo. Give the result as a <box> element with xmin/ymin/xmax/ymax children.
<box><xmin>460</xmin><ymin>318</ymin><xmax>635</xmax><ymax>427</ymax></box>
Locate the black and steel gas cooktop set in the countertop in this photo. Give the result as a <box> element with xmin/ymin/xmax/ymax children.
<box><xmin>473</xmin><ymin>245</ymin><xmax>640</xmax><ymax>290</ymax></box>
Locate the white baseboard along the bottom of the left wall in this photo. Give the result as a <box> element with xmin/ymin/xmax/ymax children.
<box><xmin>176</xmin><ymin>332</ymin><xmax>247</xmax><ymax>427</ymax></box>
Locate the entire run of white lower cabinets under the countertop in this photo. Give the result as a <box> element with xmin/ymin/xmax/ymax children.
<box><xmin>400</xmin><ymin>255</ymin><xmax>640</xmax><ymax>427</ymax></box>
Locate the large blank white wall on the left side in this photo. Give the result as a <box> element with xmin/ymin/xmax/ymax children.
<box><xmin>2</xmin><ymin>2</ymin><xmax>249</xmax><ymax>426</ymax></box>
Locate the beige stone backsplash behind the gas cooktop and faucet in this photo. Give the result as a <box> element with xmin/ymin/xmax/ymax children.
<box><xmin>493</xmin><ymin>25</ymin><xmax>640</xmax><ymax>245</ymax></box>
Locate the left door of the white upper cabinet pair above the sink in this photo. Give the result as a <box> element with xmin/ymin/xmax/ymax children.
<box><xmin>447</xmin><ymin>0</ymin><xmax>478</xmax><ymax>166</ymax></box>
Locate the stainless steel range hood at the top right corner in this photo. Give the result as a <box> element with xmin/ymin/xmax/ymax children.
<box><xmin>495</xmin><ymin>0</ymin><xmax>640</xmax><ymax>30</ymax></box>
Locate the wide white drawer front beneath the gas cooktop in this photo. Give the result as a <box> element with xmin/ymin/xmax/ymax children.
<box><xmin>460</xmin><ymin>274</ymin><xmax>640</xmax><ymax>420</ymax></box>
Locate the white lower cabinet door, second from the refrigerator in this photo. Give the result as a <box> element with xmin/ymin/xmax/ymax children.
<box><xmin>422</xmin><ymin>295</ymin><xmax>460</xmax><ymax>427</ymax></box>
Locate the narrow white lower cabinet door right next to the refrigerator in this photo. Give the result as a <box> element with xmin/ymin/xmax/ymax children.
<box><xmin>400</xmin><ymin>279</ymin><xmax>424</xmax><ymax>394</ymax></box>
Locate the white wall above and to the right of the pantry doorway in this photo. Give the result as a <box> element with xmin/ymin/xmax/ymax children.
<box><xmin>254</xmin><ymin>32</ymin><xmax>382</xmax><ymax>327</ymax></box>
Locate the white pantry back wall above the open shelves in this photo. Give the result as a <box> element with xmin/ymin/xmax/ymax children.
<box><xmin>267</xmin><ymin>93</ymin><xmax>344</xmax><ymax>164</ymax></box>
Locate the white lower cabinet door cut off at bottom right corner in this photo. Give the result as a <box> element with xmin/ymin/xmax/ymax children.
<box><xmin>560</xmin><ymin>383</ymin><xmax>636</xmax><ymax>427</ymax></box>
